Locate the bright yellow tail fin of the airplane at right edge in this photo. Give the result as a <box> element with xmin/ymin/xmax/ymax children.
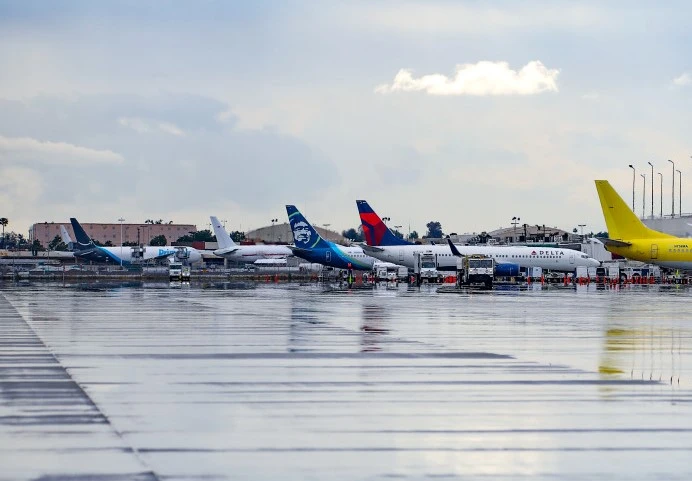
<box><xmin>596</xmin><ymin>180</ymin><xmax>675</xmax><ymax>240</ymax></box>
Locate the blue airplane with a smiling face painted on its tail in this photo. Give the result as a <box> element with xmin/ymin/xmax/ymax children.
<box><xmin>286</xmin><ymin>205</ymin><xmax>402</xmax><ymax>271</ymax></box>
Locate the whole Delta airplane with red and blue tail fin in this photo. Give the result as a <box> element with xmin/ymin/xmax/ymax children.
<box><xmin>356</xmin><ymin>200</ymin><xmax>601</xmax><ymax>277</ymax></box>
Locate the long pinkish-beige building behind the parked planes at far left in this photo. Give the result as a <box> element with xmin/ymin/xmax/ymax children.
<box><xmin>29</xmin><ymin>221</ymin><xmax>197</xmax><ymax>247</ymax></box>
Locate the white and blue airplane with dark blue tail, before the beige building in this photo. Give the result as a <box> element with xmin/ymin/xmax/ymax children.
<box><xmin>68</xmin><ymin>217</ymin><xmax>202</xmax><ymax>267</ymax></box>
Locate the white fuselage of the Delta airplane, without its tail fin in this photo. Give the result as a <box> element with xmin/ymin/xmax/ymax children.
<box><xmin>363</xmin><ymin>244</ymin><xmax>601</xmax><ymax>272</ymax></box>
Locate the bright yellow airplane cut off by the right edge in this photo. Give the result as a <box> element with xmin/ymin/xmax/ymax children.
<box><xmin>595</xmin><ymin>180</ymin><xmax>692</xmax><ymax>270</ymax></box>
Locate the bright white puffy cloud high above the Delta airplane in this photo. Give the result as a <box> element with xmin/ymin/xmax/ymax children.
<box><xmin>375</xmin><ymin>60</ymin><xmax>560</xmax><ymax>96</ymax></box>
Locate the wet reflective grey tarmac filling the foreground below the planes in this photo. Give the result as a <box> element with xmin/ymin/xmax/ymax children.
<box><xmin>0</xmin><ymin>283</ymin><xmax>692</xmax><ymax>480</ymax></box>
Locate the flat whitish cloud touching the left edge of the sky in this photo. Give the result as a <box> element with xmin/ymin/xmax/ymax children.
<box><xmin>0</xmin><ymin>135</ymin><xmax>124</xmax><ymax>165</ymax></box>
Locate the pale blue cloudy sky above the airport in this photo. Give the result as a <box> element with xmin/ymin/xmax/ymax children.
<box><xmin>0</xmin><ymin>0</ymin><xmax>692</xmax><ymax>238</ymax></box>
